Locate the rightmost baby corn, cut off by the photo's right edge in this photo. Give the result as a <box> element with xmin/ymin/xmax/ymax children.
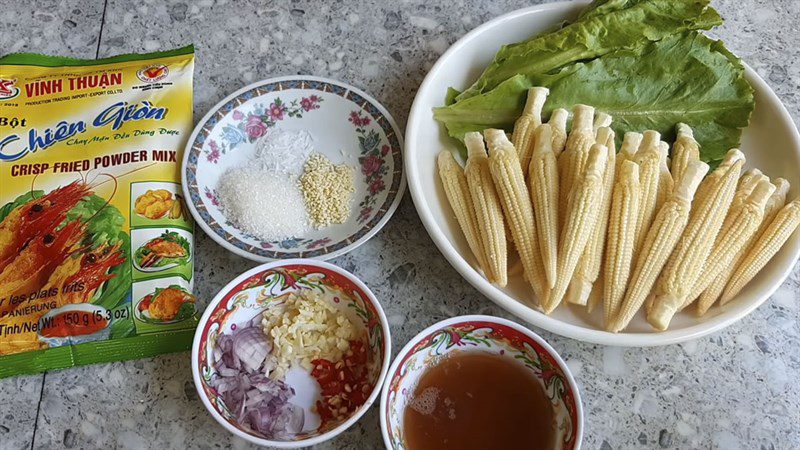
<box><xmin>720</xmin><ymin>199</ymin><xmax>800</xmax><ymax>304</ymax></box>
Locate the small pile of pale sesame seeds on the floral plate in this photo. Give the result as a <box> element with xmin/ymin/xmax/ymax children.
<box><xmin>300</xmin><ymin>153</ymin><xmax>355</xmax><ymax>228</ymax></box>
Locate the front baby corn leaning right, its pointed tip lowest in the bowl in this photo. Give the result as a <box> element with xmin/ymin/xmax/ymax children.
<box><xmin>606</xmin><ymin>161</ymin><xmax>708</xmax><ymax>333</ymax></box>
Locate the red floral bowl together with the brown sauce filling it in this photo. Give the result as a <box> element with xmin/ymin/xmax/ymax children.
<box><xmin>381</xmin><ymin>315</ymin><xmax>583</xmax><ymax>450</ymax></box>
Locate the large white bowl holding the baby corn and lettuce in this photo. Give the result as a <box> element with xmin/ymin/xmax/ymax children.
<box><xmin>404</xmin><ymin>2</ymin><xmax>800</xmax><ymax>346</ymax></box>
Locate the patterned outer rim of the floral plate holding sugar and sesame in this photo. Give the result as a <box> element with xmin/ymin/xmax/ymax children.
<box><xmin>181</xmin><ymin>75</ymin><xmax>407</xmax><ymax>263</ymax></box>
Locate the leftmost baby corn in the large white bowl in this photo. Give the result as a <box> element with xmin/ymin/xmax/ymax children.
<box><xmin>437</xmin><ymin>150</ymin><xmax>488</xmax><ymax>270</ymax></box>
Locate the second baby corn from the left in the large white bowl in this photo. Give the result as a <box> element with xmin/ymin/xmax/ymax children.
<box><xmin>464</xmin><ymin>132</ymin><xmax>508</xmax><ymax>286</ymax></box>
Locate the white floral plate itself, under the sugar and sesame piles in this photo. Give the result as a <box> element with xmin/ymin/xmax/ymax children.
<box><xmin>181</xmin><ymin>76</ymin><xmax>405</xmax><ymax>262</ymax></box>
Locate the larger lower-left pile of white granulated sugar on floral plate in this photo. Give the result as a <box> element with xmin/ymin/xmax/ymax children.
<box><xmin>217</xmin><ymin>167</ymin><xmax>310</xmax><ymax>241</ymax></box>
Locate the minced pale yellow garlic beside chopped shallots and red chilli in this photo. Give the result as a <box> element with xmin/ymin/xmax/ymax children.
<box><xmin>261</xmin><ymin>289</ymin><xmax>358</xmax><ymax>379</ymax></box>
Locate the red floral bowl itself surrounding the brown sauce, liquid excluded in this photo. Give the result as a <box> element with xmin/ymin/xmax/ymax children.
<box><xmin>380</xmin><ymin>315</ymin><xmax>583</xmax><ymax>450</ymax></box>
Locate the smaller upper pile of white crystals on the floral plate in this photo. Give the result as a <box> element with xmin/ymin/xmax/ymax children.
<box><xmin>255</xmin><ymin>128</ymin><xmax>314</xmax><ymax>174</ymax></box>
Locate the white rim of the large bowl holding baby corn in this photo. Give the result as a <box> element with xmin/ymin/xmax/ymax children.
<box><xmin>403</xmin><ymin>1</ymin><xmax>800</xmax><ymax>347</ymax></box>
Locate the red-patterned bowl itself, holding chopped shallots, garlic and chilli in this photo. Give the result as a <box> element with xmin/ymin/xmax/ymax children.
<box><xmin>192</xmin><ymin>259</ymin><xmax>391</xmax><ymax>448</ymax></box>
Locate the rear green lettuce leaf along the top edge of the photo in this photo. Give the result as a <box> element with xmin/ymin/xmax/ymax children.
<box><xmin>456</xmin><ymin>0</ymin><xmax>722</xmax><ymax>101</ymax></box>
